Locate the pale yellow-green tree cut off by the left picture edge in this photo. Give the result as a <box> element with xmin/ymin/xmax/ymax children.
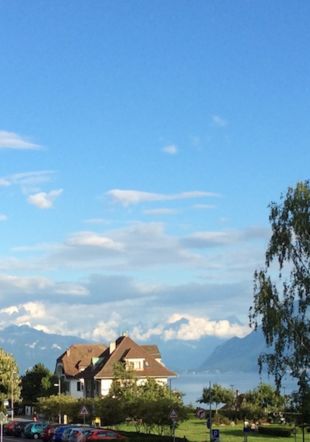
<box><xmin>0</xmin><ymin>348</ymin><xmax>20</xmax><ymax>410</ymax></box>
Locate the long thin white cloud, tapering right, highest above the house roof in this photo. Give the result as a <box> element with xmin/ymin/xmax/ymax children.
<box><xmin>106</xmin><ymin>189</ymin><xmax>219</xmax><ymax>206</ymax></box>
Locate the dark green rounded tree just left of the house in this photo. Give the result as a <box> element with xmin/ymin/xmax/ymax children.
<box><xmin>21</xmin><ymin>363</ymin><xmax>57</xmax><ymax>403</ymax></box>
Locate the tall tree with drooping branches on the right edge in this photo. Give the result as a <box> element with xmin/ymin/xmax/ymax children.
<box><xmin>249</xmin><ymin>181</ymin><xmax>310</xmax><ymax>392</ymax></box>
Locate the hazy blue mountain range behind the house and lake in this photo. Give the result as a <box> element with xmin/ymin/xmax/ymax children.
<box><xmin>0</xmin><ymin>325</ymin><xmax>266</xmax><ymax>374</ymax></box>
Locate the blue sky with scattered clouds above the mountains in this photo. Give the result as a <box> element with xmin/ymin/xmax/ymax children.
<box><xmin>0</xmin><ymin>0</ymin><xmax>310</xmax><ymax>342</ymax></box>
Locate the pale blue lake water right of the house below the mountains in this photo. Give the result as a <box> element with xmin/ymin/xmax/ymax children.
<box><xmin>171</xmin><ymin>372</ymin><xmax>295</xmax><ymax>406</ymax></box>
